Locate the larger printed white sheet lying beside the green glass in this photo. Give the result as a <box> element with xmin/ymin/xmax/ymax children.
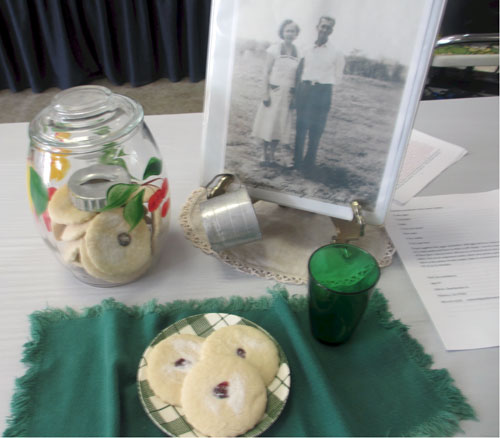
<box><xmin>386</xmin><ymin>190</ymin><xmax>499</xmax><ymax>350</ymax></box>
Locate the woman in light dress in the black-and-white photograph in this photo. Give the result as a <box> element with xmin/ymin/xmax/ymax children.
<box><xmin>252</xmin><ymin>20</ymin><xmax>300</xmax><ymax>166</ymax></box>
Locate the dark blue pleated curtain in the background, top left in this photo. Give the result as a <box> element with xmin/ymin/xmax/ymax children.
<box><xmin>0</xmin><ymin>0</ymin><xmax>211</xmax><ymax>92</ymax></box>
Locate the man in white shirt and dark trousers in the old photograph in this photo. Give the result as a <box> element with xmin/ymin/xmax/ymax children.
<box><xmin>293</xmin><ymin>16</ymin><xmax>345</xmax><ymax>172</ymax></box>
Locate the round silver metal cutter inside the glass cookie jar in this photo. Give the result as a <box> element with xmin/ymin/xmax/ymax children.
<box><xmin>68</xmin><ymin>164</ymin><xmax>130</xmax><ymax>211</ymax></box>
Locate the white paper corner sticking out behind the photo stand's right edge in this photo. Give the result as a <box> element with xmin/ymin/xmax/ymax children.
<box><xmin>394</xmin><ymin>129</ymin><xmax>467</xmax><ymax>204</ymax></box>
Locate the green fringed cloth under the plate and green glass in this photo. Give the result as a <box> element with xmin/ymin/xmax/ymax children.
<box><xmin>4</xmin><ymin>287</ymin><xmax>474</xmax><ymax>436</ymax></box>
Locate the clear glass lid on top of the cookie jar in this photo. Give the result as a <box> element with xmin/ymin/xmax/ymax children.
<box><xmin>29</xmin><ymin>85</ymin><xmax>144</xmax><ymax>153</ymax></box>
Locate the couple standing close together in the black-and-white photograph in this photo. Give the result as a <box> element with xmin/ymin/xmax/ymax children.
<box><xmin>252</xmin><ymin>16</ymin><xmax>345</xmax><ymax>171</ymax></box>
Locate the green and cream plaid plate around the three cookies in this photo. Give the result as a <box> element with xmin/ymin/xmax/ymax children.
<box><xmin>137</xmin><ymin>313</ymin><xmax>290</xmax><ymax>437</ymax></box>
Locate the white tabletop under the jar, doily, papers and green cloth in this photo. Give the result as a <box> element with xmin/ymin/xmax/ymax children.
<box><xmin>0</xmin><ymin>98</ymin><xmax>499</xmax><ymax>436</ymax></box>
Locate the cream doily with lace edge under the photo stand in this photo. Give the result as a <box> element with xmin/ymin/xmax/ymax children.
<box><xmin>179</xmin><ymin>188</ymin><xmax>395</xmax><ymax>284</ymax></box>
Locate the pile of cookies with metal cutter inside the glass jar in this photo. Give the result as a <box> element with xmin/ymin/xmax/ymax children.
<box><xmin>48</xmin><ymin>165</ymin><xmax>170</xmax><ymax>286</ymax></box>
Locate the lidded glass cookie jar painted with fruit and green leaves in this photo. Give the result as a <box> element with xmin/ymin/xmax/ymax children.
<box><xmin>27</xmin><ymin>85</ymin><xmax>170</xmax><ymax>287</ymax></box>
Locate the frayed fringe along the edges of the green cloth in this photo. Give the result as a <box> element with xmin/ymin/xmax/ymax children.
<box><xmin>4</xmin><ymin>285</ymin><xmax>476</xmax><ymax>436</ymax></box>
